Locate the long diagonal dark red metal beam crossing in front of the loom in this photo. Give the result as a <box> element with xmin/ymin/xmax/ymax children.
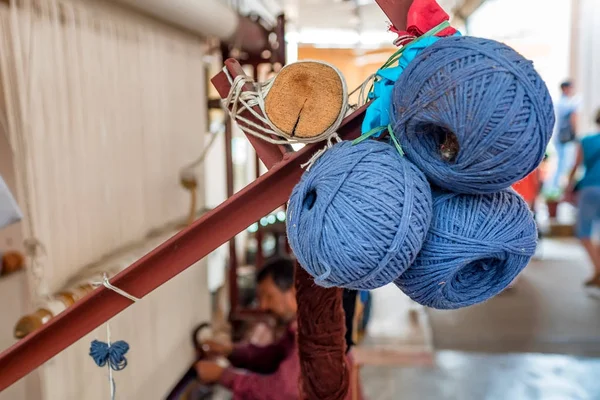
<box><xmin>0</xmin><ymin>62</ymin><xmax>364</xmax><ymax>391</ymax></box>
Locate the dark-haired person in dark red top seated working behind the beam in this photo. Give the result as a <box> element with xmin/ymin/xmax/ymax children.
<box><xmin>196</xmin><ymin>258</ymin><xmax>361</xmax><ymax>400</ymax></box>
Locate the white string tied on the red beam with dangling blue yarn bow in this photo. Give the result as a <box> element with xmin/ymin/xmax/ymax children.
<box><xmin>90</xmin><ymin>273</ymin><xmax>140</xmax><ymax>400</ymax></box>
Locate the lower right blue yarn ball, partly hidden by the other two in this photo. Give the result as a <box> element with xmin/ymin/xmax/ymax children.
<box><xmin>395</xmin><ymin>189</ymin><xmax>537</xmax><ymax>309</ymax></box>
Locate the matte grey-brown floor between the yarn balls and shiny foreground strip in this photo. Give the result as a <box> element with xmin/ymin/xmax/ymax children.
<box><xmin>429</xmin><ymin>240</ymin><xmax>600</xmax><ymax>357</ymax></box>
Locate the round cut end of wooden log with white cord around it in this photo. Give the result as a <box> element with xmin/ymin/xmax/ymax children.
<box><xmin>265</xmin><ymin>61</ymin><xmax>345</xmax><ymax>139</ymax></box>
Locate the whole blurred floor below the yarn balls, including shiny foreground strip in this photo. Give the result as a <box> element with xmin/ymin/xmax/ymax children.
<box><xmin>361</xmin><ymin>240</ymin><xmax>600</xmax><ymax>400</ymax></box>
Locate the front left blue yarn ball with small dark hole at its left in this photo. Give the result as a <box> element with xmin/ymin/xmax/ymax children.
<box><xmin>287</xmin><ymin>140</ymin><xmax>432</xmax><ymax>290</ymax></box>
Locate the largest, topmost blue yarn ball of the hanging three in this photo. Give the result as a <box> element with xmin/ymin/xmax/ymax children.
<box><xmin>392</xmin><ymin>37</ymin><xmax>554</xmax><ymax>194</ymax></box>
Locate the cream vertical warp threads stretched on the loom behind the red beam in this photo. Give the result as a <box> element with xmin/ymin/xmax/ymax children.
<box><xmin>0</xmin><ymin>0</ymin><xmax>210</xmax><ymax>400</ymax></box>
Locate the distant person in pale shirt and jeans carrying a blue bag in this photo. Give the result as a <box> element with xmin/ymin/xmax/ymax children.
<box><xmin>547</xmin><ymin>81</ymin><xmax>578</xmax><ymax>193</ymax></box>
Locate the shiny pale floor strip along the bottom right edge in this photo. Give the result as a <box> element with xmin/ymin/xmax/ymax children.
<box><xmin>361</xmin><ymin>351</ymin><xmax>600</xmax><ymax>400</ymax></box>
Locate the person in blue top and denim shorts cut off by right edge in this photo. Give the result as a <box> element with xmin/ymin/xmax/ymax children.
<box><xmin>565</xmin><ymin>109</ymin><xmax>600</xmax><ymax>294</ymax></box>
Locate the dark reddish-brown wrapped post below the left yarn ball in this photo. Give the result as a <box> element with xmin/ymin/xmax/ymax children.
<box><xmin>296</xmin><ymin>263</ymin><xmax>350</xmax><ymax>400</ymax></box>
